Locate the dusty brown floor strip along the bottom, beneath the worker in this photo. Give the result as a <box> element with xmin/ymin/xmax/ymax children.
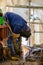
<box><xmin>0</xmin><ymin>61</ymin><xmax>40</xmax><ymax>65</ymax></box>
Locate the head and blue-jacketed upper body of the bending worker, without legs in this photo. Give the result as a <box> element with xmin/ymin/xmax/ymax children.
<box><xmin>4</xmin><ymin>12</ymin><xmax>31</xmax><ymax>54</ymax></box>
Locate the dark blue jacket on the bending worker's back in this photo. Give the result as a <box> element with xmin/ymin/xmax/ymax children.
<box><xmin>4</xmin><ymin>12</ymin><xmax>27</xmax><ymax>33</ymax></box>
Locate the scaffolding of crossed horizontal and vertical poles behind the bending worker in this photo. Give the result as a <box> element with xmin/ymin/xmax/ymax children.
<box><xmin>6</xmin><ymin>0</ymin><xmax>43</xmax><ymax>45</ymax></box>
